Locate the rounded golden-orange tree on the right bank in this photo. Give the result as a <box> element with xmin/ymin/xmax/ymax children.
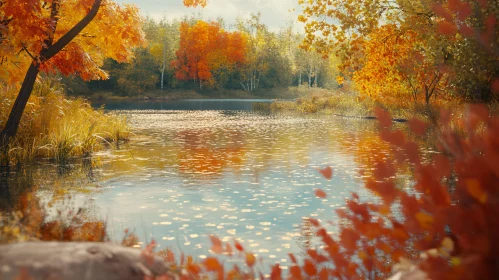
<box><xmin>352</xmin><ymin>24</ymin><xmax>445</xmax><ymax>104</ymax></box>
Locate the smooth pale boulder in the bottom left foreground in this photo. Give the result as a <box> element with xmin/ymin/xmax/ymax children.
<box><xmin>0</xmin><ymin>242</ymin><xmax>175</xmax><ymax>280</ymax></box>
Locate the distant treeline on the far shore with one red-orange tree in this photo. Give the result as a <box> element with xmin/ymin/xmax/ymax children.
<box><xmin>63</xmin><ymin>14</ymin><xmax>338</xmax><ymax>97</ymax></box>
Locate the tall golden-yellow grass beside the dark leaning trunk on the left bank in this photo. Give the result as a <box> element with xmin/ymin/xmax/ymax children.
<box><xmin>0</xmin><ymin>78</ymin><xmax>130</xmax><ymax>164</ymax></box>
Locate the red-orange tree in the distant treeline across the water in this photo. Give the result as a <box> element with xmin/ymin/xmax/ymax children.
<box><xmin>172</xmin><ymin>20</ymin><xmax>246</xmax><ymax>88</ymax></box>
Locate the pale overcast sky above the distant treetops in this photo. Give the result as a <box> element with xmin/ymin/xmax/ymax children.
<box><xmin>117</xmin><ymin>0</ymin><xmax>301</xmax><ymax>31</ymax></box>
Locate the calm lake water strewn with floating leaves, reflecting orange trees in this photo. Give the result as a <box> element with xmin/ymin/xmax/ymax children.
<box><xmin>0</xmin><ymin>100</ymin><xmax>398</xmax><ymax>269</ymax></box>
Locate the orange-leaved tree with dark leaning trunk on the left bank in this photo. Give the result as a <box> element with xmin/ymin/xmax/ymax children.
<box><xmin>0</xmin><ymin>0</ymin><xmax>206</xmax><ymax>153</ymax></box>
